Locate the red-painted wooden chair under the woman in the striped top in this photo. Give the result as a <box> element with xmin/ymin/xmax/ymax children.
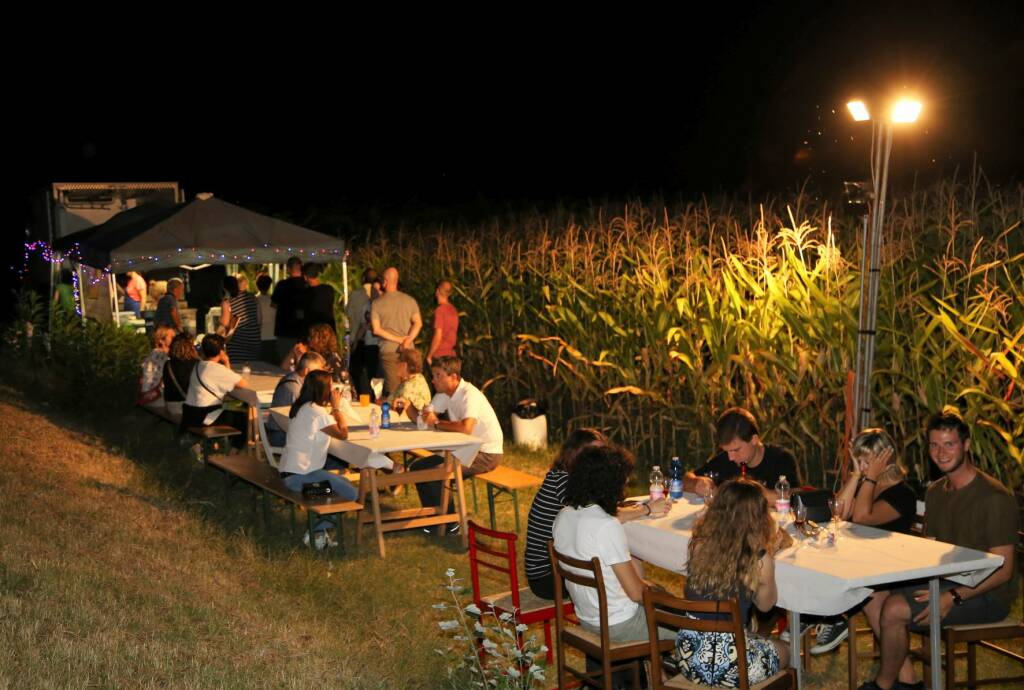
<box><xmin>469</xmin><ymin>520</ymin><xmax>572</xmax><ymax>663</ymax></box>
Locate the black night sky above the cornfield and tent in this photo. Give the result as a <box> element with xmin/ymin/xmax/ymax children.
<box><xmin>4</xmin><ymin>2</ymin><xmax>1024</xmax><ymax>264</ymax></box>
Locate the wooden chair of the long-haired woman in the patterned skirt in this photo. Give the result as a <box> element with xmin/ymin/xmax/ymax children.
<box><xmin>643</xmin><ymin>588</ymin><xmax>797</xmax><ymax>690</ymax></box>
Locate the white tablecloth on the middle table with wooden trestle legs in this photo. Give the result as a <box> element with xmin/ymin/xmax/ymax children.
<box><xmin>270</xmin><ymin>405</ymin><xmax>480</xmax><ymax>470</ymax></box>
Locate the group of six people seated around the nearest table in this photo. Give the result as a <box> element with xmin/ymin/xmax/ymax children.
<box><xmin>525</xmin><ymin>408</ymin><xmax>1018</xmax><ymax>690</ymax></box>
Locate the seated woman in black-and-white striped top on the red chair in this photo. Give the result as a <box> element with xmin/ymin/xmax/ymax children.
<box><xmin>524</xmin><ymin>429</ymin><xmax>670</xmax><ymax>599</ymax></box>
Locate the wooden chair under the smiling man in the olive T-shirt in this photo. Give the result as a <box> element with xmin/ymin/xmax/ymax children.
<box><xmin>922</xmin><ymin>531</ymin><xmax>1024</xmax><ymax>690</ymax></box>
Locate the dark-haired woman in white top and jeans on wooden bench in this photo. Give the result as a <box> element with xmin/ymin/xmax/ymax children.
<box><xmin>278</xmin><ymin>371</ymin><xmax>357</xmax><ymax>550</ymax></box>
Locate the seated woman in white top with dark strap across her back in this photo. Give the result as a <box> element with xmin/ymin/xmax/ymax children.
<box><xmin>180</xmin><ymin>335</ymin><xmax>249</xmax><ymax>451</ymax></box>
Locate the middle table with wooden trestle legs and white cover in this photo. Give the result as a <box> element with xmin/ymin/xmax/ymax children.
<box><xmin>270</xmin><ymin>406</ymin><xmax>480</xmax><ymax>557</ymax></box>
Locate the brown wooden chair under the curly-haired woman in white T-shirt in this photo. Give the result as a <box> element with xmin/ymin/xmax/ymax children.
<box><xmin>548</xmin><ymin>540</ymin><xmax>648</xmax><ymax>690</ymax></box>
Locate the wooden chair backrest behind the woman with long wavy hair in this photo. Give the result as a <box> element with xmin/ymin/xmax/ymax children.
<box><xmin>643</xmin><ymin>587</ymin><xmax>750</xmax><ymax>690</ymax></box>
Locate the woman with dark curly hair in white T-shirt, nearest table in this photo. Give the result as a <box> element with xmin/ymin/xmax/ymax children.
<box><xmin>552</xmin><ymin>445</ymin><xmax>675</xmax><ymax>642</ymax></box>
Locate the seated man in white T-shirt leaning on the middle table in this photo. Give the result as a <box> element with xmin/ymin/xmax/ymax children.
<box><xmin>403</xmin><ymin>357</ymin><xmax>505</xmax><ymax>533</ymax></box>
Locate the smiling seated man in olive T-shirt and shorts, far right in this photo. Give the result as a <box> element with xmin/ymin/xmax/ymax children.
<box><xmin>860</xmin><ymin>409</ymin><xmax>1018</xmax><ymax>690</ymax></box>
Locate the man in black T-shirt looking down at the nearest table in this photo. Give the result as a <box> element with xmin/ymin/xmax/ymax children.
<box><xmin>683</xmin><ymin>407</ymin><xmax>800</xmax><ymax>501</ymax></box>
